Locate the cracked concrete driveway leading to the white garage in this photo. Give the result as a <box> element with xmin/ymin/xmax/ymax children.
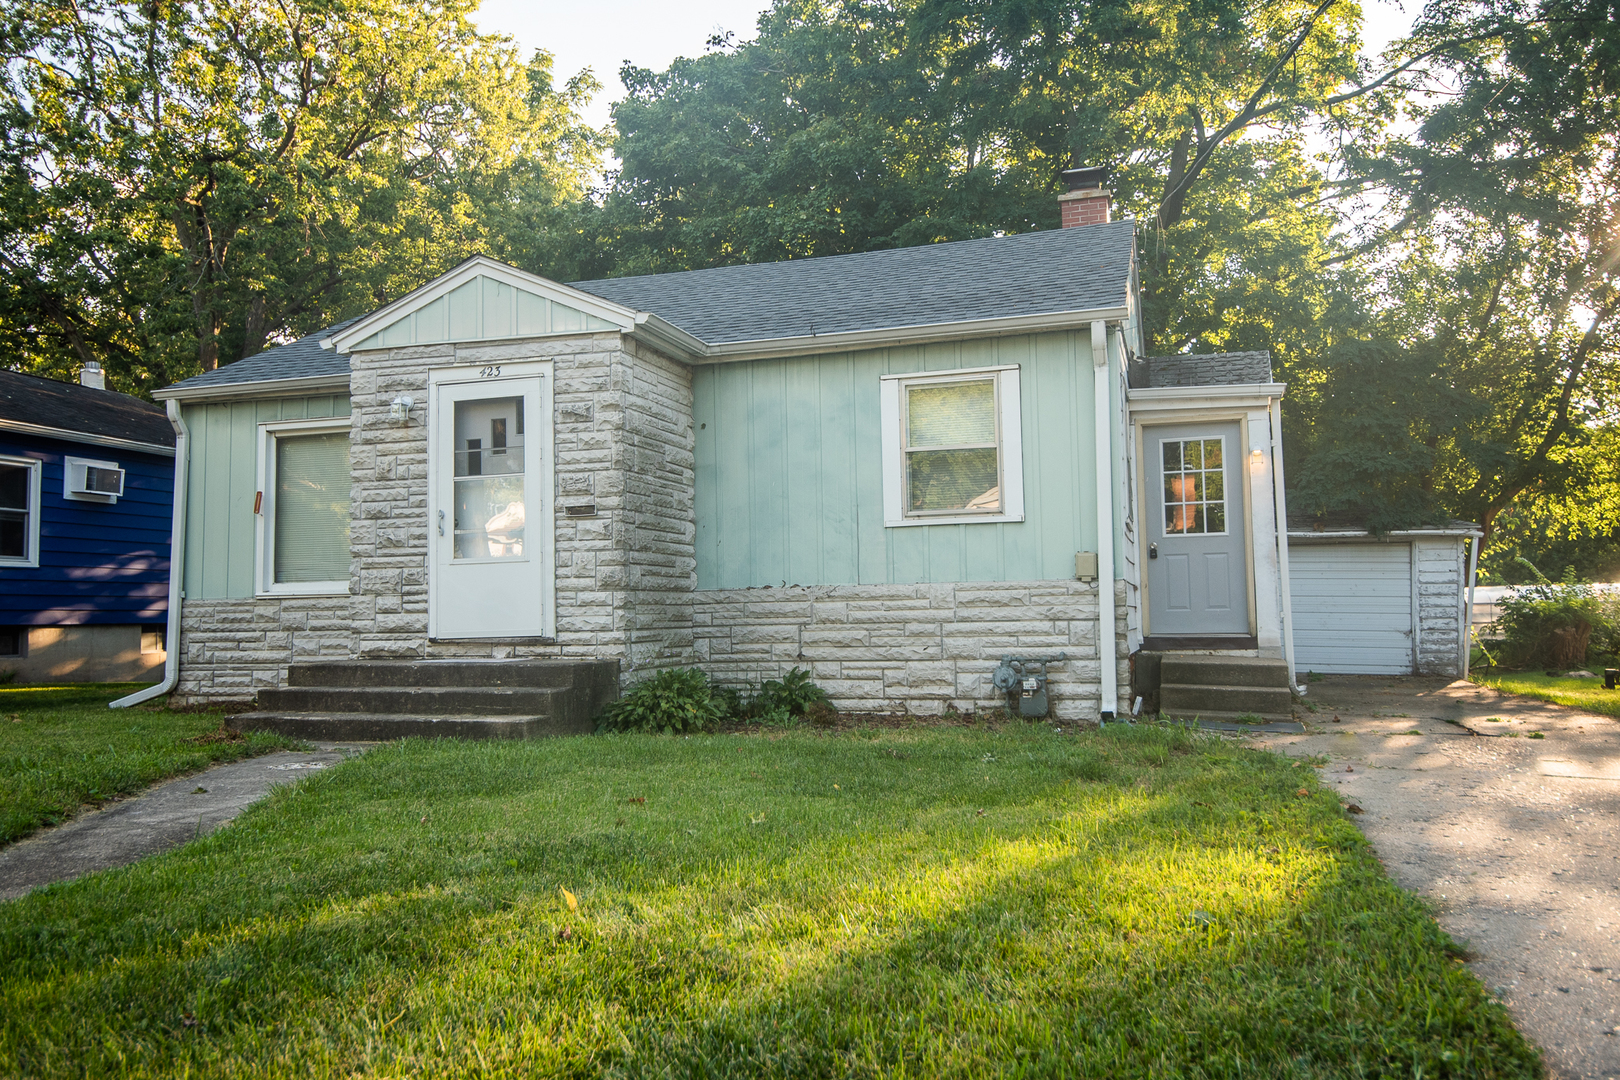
<box><xmin>1256</xmin><ymin>675</ymin><xmax>1620</xmax><ymax>1078</ymax></box>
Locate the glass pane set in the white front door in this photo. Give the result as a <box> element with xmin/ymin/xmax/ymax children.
<box><xmin>452</xmin><ymin>397</ymin><xmax>528</xmax><ymax>559</ymax></box>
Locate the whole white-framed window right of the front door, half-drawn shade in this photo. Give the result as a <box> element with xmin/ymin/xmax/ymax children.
<box><xmin>880</xmin><ymin>366</ymin><xmax>1024</xmax><ymax>526</ymax></box>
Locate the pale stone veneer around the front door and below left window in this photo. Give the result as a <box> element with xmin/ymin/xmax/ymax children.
<box><xmin>178</xmin><ymin>332</ymin><xmax>697</xmax><ymax>699</ymax></box>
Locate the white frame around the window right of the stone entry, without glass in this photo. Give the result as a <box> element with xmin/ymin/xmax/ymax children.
<box><xmin>878</xmin><ymin>364</ymin><xmax>1024</xmax><ymax>529</ymax></box>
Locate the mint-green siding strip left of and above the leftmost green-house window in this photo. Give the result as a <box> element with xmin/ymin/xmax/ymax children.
<box><xmin>181</xmin><ymin>393</ymin><xmax>348</xmax><ymax>599</ymax></box>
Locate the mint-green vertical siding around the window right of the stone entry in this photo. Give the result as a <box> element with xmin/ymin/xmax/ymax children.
<box><xmin>692</xmin><ymin>330</ymin><xmax>1097</xmax><ymax>589</ymax></box>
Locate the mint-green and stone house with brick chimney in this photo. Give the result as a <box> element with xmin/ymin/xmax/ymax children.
<box><xmin>145</xmin><ymin>170</ymin><xmax>1291</xmax><ymax>730</ymax></box>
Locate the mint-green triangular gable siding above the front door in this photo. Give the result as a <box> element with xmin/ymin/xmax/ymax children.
<box><xmin>355</xmin><ymin>274</ymin><xmax>617</xmax><ymax>348</ymax></box>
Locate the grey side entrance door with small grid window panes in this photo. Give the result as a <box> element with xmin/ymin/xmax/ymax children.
<box><xmin>1142</xmin><ymin>423</ymin><xmax>1252</xmax><ymax>636</ymax></box>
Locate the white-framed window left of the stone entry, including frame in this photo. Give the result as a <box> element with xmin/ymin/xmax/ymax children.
<box><xmin>256</xmin><ymin>416</ymin><xmax>350</xmax><ymax>596</ymax></box>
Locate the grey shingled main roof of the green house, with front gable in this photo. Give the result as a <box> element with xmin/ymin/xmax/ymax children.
<box><xmin>154</xmin><ymin>222</ymin><xmax>1136</xmax><ymax>400</ymax></box>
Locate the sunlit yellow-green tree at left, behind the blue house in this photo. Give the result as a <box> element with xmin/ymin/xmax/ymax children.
<box><xmin>0</xmin><ymin>0</ymin><xmax>599</xmax><ymax>390</ymax></box>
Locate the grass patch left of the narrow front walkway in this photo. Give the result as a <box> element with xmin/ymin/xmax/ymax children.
<box><xmin>0</xmin><ymin>683</ymin><xmax>296</xmax><ymax>844</ymax></box>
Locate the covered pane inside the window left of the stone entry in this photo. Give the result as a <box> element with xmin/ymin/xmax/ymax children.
<box><xmin>275</xmin><ymin>432</ymin><xmax>348</xmax><ymax>585</ymax></box>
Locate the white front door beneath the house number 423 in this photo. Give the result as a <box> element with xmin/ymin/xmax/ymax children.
<box><xmin>428</xmin><ymin>364</ymin><xmax>554</xmax><ymax>638</ymax></box>
